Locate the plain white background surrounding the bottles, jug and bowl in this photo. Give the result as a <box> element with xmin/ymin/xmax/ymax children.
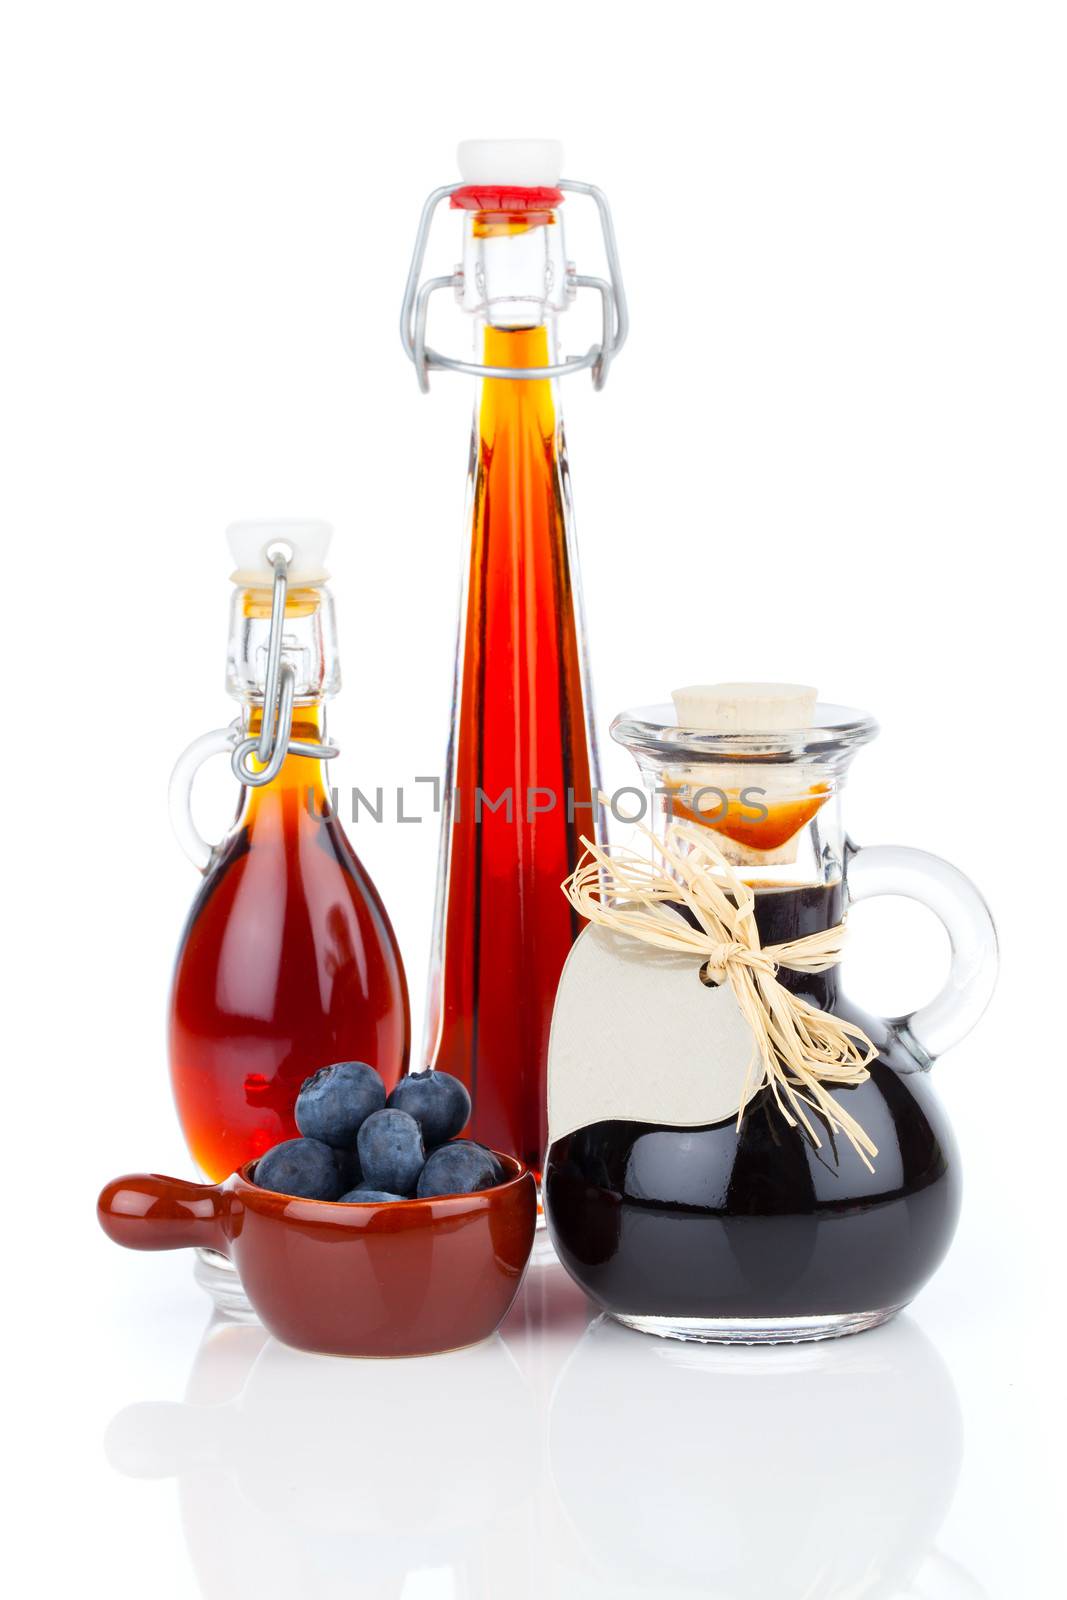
<box><xmin>0</xmin><ymin>0</ymin><xmax>1067</xmax><ymax>1600</ymax></box>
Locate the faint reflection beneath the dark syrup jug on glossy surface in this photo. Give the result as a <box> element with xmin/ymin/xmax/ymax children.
<box><xmin>549</xmin><ymin>1317</ymin><xmax>981</xmax><ymax>1600</ymax></box>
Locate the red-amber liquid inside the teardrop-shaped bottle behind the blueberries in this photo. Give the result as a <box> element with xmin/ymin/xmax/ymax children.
<box><xmin>170</xmin><ymin>707</ymin><xmax>410</xmax><ymax>1179</ymax></box>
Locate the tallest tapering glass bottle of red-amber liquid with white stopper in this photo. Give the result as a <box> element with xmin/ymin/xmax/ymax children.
<box><xmin>413</xmin><ymin>141</ymin><xmax>627</xmax><ymax>1171</ymax></box>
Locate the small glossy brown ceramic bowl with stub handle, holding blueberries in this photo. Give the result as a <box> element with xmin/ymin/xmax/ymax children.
<box><xmin>98</xmin><ymin>1155</ymin><xmax>537</xmax><ymax>1355</ymax></box>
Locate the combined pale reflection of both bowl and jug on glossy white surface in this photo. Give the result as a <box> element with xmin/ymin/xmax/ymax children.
<box><xmin>107</xmin><ymin>1264</ymin><xmax>982</xmax><ymax>1600</ymax></box>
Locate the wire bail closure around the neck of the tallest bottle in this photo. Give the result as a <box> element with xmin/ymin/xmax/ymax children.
<box><xmin>404</xmin><ymin>178</ymin><xmax>630</xmax><ymax>392</ymax></box>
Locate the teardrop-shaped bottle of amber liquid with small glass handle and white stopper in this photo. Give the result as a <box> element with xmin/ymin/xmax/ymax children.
<box><xmin>170</xmin><ymin>523</ymin><xmax>410</xmax><ymax>1179</ymax></box>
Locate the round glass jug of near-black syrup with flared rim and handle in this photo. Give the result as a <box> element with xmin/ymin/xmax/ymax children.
<box><xmin>544</xmin><ymin>685</ymin><xmax>997</xmax><ymax>1344</ymax></box>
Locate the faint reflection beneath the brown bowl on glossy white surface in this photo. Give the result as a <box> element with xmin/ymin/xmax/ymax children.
<box><xmin>107</xmin><ymin>1322</ymin><xmax>536</xmax><ymax>1600</ymax></box>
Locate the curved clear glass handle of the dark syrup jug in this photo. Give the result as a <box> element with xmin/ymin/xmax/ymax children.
<box><xmin>848</xmin><ymin>843</ymin><xmax>997</xmax><ymax>1067</ymax></box>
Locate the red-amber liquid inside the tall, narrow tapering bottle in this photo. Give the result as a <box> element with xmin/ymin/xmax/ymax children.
<box><xmin>432</xmin><ymin>328</ymin><xmax>595</xmax><ymax>1170</ymax></box>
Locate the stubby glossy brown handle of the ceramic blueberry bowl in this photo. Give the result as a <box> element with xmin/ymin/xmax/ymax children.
<box><xmin>96</xmin><ymin>1173</ymin><xmax>234</xmax><ymax>1256</ymax></box>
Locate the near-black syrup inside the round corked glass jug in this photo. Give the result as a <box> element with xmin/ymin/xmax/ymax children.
<box><xmin>544</xmin><ymin>883</ymin><xmax>960</xmax><ymax>1320</ymax></box>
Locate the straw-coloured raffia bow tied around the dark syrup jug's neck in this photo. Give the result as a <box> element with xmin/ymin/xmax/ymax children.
<box><xmin>561</xmin><ymin>821</ymin><xmax>878</xmax><ymax>1171</ymax></box>
